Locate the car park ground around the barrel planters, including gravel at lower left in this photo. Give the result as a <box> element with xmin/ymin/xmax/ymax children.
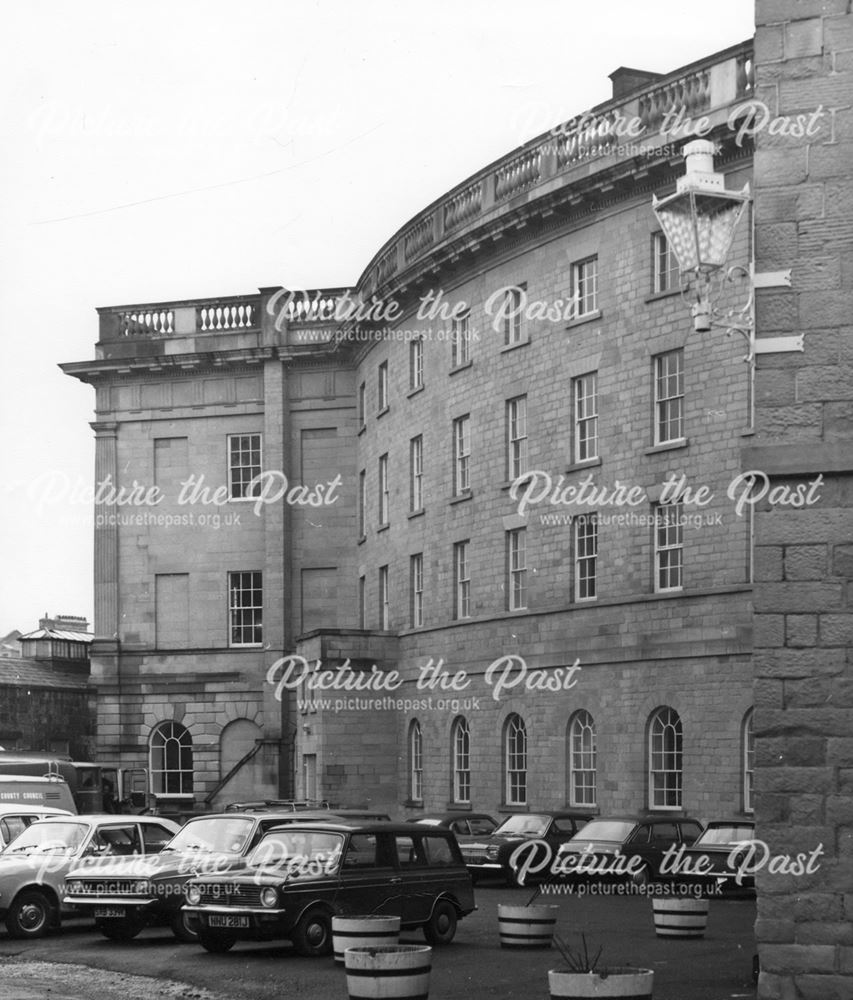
<box><xmin>0</xmin><ymin>883</ymin><xmax>755</xmax><ymax>1000</ymax></box>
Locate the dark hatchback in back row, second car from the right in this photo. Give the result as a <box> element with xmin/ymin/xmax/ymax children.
<box><xmin>556</xmin><ymin>813</ymin><xmax>702</xmax><ymax>885</ymax></box>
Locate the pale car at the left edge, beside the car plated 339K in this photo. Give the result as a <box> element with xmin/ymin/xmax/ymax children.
<box><xmin>0</xmin><ymin>814</ymin><xmax>178</xmax><ymax>938</ymax></box>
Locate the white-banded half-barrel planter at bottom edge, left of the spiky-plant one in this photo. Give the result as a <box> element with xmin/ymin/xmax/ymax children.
<box><xmin>344</xmin><ymin>944</ymin><xmax>432</xmax><ymax>1000</ymax></box>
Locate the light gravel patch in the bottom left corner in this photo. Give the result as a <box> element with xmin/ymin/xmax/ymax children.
<box><xmin>0</xmin><ymin>960</ymin><xmax>222</xmax><ymax>1000</ymax></box>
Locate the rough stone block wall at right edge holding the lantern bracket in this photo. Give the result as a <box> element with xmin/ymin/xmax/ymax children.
<box><xmin>744</xmin><ymin>0</ymin><xmax>853</xmax><ymax>1000</ymax></box>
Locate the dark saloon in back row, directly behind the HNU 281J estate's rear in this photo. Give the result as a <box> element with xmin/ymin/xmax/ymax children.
<box><xmin>462</xmin><ymin>809</ymin><xmax>590</xmax><ymax>885</ymax></box>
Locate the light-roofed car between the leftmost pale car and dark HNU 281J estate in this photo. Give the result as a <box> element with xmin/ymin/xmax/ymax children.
<box><xmin>64</xmin><ymin>805</ymin><xmax>362</xmax><ymax>941</ymax></box>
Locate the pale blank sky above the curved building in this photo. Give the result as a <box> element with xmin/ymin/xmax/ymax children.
<box><xmin>0</xmin><ymin>0</ymin><xmax>754</xmax><ymax>635</ymax></box>
